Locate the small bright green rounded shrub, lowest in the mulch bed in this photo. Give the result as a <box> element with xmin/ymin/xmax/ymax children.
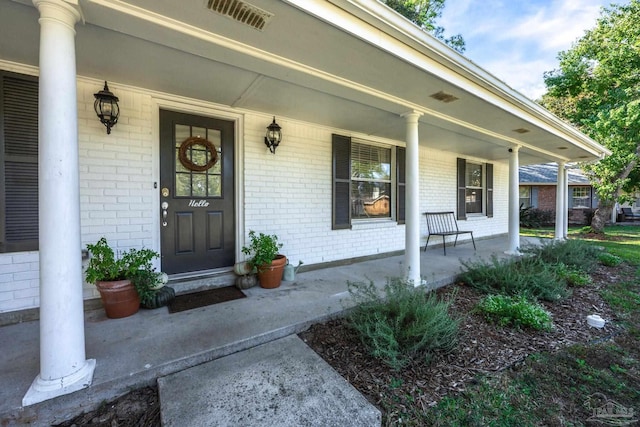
<box><xmin>477</xmin><ymin>295</ymin><xmax>553</xmax><ymax>331</ymax></box>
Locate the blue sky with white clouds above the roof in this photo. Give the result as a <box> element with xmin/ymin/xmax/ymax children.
<box><xmin>436</xmin><ymin>0</ymin><xmax>628</xmax><ymax>100</ymax></box>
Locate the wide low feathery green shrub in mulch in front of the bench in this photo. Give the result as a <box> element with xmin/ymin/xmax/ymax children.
<box><xmin>459</xmin><ymin>256</ymin><xmax>569</xmax><ymax>301</ymax></box>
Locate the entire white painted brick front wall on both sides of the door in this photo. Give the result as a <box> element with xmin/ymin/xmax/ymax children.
<box><xmin>0</xmin><ymin>73</ymin><xmax>508</xmax><ymax>312</ymax></box>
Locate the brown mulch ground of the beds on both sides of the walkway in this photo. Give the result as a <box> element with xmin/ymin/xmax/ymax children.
<box><xmin>55</xmin><ymin>265</ymin><xmax>634</xmax><ymax>427</ymax></box>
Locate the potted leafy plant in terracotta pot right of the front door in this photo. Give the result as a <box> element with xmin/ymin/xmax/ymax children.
<box><xmin>242</xmin><ymin>230</ymin><xmax>287</xmax><ymax>289</ymax></box>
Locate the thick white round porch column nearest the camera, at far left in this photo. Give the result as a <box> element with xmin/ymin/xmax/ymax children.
<box><xmin>22</xmin><ymin>0</ymin><xmax>95</xmax><ymax>406</ymax></box>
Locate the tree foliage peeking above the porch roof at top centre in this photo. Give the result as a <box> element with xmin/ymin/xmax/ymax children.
<box><xmin>384</xmin><ymin>0</ymin><xmax>466</xmax><ymax>53</ymax></box>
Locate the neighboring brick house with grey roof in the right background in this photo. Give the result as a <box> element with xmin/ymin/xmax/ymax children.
<box><xmin>520</xmin><ymin>163</ymin><xmax>598</xmax><ymax>224</ymax></box>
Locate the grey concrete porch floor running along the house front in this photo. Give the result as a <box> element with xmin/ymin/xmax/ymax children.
<box><xmin>0</xmin><ymin>237</ymin><xmax>533</xmax><ymax>426</ymax></box>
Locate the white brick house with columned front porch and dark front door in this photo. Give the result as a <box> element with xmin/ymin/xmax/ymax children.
<box><xmin>0</xmin><ymin>0</ymin><xmax>608</xmax><ymax>405</ymax></box>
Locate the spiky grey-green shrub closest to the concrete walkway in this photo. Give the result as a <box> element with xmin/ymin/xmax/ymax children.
<box><xmin>349</xmin><ymin>279</ymin><xmax>459</xmax><ymax>369</ymax></box>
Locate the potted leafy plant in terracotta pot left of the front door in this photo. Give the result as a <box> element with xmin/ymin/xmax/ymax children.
<box><xmin>86</xmin><ymin>237</ymin><xmax>158</xmax><ymax>318</ymax></box>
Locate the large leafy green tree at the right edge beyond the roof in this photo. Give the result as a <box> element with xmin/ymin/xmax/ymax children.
<box><xmin>541</xmin><ymin>0</ymin><xmax>640</xmax><ymax>233</ymax></box>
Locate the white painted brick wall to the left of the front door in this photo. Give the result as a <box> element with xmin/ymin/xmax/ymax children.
<box><xmin>0</xmin><ymin>79</ymin><xmax>158</xmax><ymax>312</ymax></box>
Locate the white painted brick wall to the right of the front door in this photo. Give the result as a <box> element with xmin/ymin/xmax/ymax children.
<box><xmin>244</xmin><ymin>115</ymin><xmax>508</xmax><ymax>264</ymax></box>
